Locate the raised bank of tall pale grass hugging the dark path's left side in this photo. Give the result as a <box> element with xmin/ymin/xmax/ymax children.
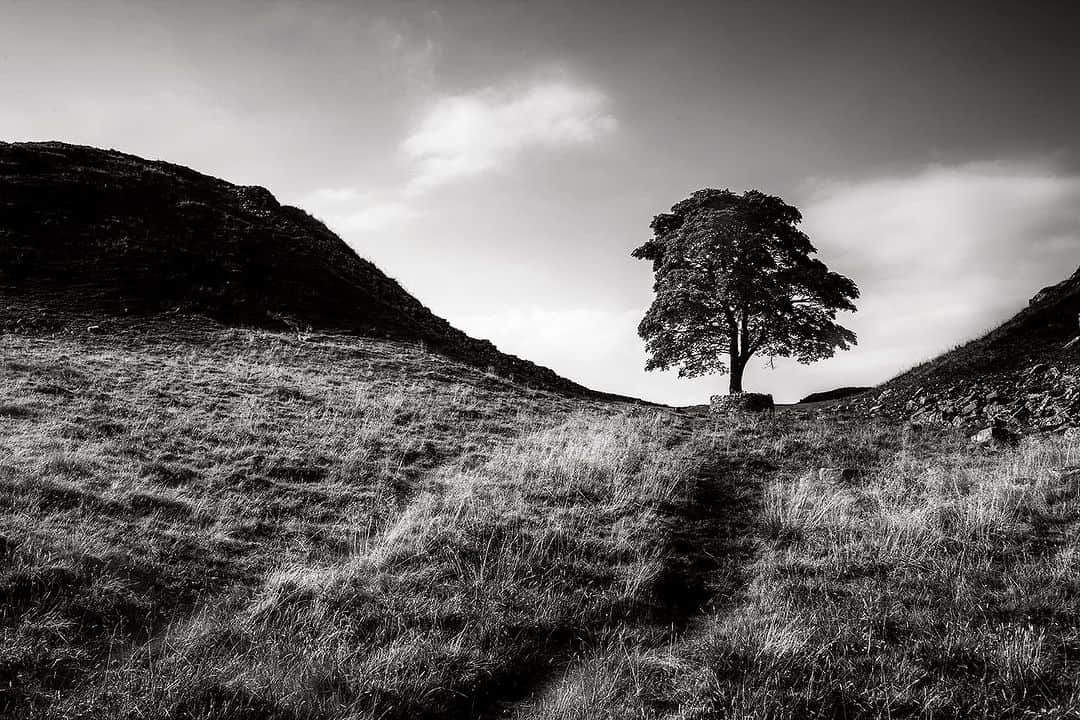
<box><xmin>88</xmin><ymin>411</ymin><xmax>694</xmax><ymax>718</ymax></box>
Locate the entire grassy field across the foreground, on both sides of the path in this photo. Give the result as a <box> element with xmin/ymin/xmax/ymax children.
<box><xmin>0</xmin><ymin>325</ymin><xmax>1080</xmax><ymax>719</ymax></box>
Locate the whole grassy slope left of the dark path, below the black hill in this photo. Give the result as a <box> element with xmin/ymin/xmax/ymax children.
<box><xmin>0</xmin><ymin>330</ymin><xmax>698</xmax><ymax>717</ymax></box>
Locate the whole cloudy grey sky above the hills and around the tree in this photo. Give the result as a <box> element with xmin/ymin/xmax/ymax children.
<box><xmin>0</xmin><ymin>0</ymin><xmax>1080</xmax><ymax>405</ymax></box>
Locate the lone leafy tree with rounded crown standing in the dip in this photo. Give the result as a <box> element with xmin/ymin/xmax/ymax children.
<box><xmin>633</xmin><ymin>189</ymin><xmax>859</xmax><ymax>393</ymax></box>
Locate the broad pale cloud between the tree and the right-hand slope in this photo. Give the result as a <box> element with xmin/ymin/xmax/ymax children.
<box><xmin>777</xmin><ymin>162</ymin><xmax>1080</xmax><ymax>395</ymax></box>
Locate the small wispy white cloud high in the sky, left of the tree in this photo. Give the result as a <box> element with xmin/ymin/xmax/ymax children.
<box><xmin>402</xmin><ymin>80</ymin><xmax>617</xmax><ymax>192</ymax></box>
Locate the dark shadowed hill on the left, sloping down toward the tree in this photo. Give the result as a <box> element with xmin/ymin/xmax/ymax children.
<box><xmin>0</xmin><ymin>142</ymin><xmax>585</xmax><ymax>392</ymax></box>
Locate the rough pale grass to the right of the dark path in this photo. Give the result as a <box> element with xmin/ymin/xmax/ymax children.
<box><xmin>561</xmin><ymin>418</ymin><xmax>1080</xmax><ymax>720</ymax></box>
